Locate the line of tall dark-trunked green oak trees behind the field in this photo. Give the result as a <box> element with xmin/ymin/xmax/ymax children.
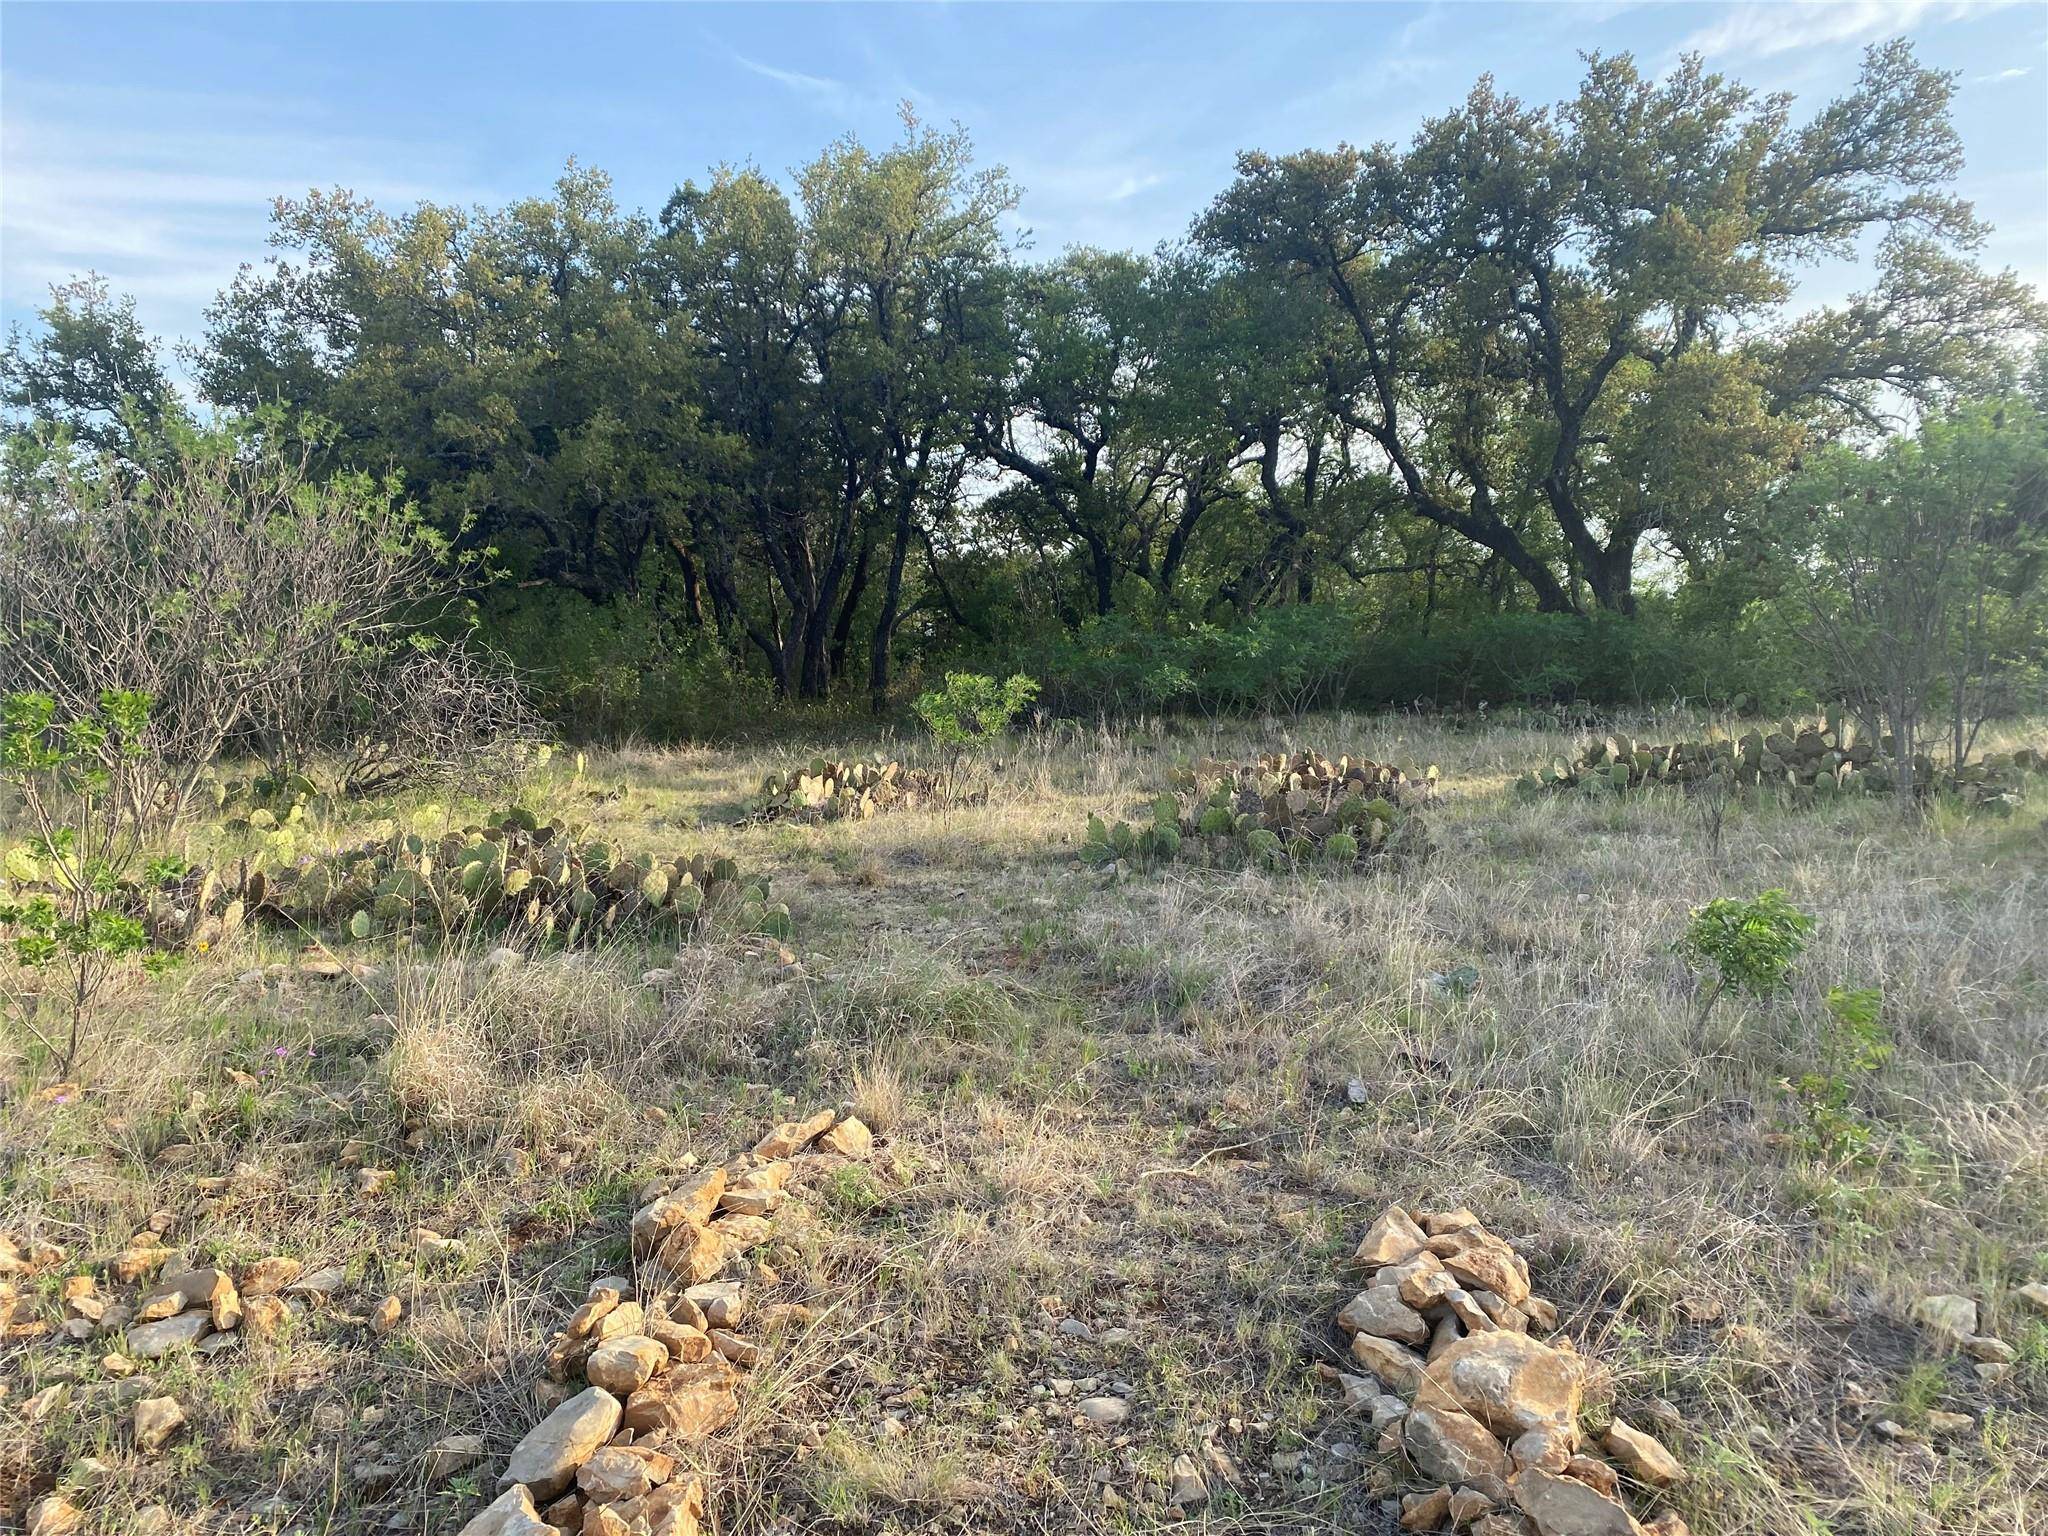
<box><xmin>4</xmin><ymin>43</ymin><xmax>2048</xmax><ymax>733</ymax></box>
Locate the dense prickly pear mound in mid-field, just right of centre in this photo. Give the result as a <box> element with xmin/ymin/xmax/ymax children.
<box><xmin>1081</xmin><ymin>754</ymin><xmax>1438</xmax><ymax>870</ymax></box>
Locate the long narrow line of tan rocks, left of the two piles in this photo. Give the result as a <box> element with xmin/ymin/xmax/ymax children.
<box><xmin>461</xmin><ymin>1110</ymin><xmax>874</xmax><ymax>1536</ymax></box>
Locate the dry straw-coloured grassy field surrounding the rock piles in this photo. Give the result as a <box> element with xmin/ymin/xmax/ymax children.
<box><xmin>0</xmin><ymin>717</ymin><xmax>2048</xmax><ymax>1536</ymax></box>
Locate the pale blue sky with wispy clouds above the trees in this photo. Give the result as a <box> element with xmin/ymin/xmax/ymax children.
<box><xmin>0</xmin><ymin>0</ymin><xmax>2048</xmax><ymax>360</ymax></box>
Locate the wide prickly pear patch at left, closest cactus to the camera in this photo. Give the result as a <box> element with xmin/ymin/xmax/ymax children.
<box><xmin>147</xmin><ymin>809</ymin><xmax>791</xmax><ymax>944</ymax></box>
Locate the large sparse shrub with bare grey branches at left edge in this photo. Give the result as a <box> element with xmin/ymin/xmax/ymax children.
<box><xmin>0</xmin><ymin>434</ymin><xmax>530</xmax><ymax>815</ymax></box>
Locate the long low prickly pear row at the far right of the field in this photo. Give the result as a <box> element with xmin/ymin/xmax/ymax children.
<box><xmin>1516</xmin><ymin>713</ymin><xmax>2048</xmax><ymax>805</ymax></box>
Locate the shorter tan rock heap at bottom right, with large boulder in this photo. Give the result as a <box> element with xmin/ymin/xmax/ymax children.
<box><xmin>1323</xmin><ymin>1206</ymin><xmax>1686</xmax><ymax>1536</ymax></box>
